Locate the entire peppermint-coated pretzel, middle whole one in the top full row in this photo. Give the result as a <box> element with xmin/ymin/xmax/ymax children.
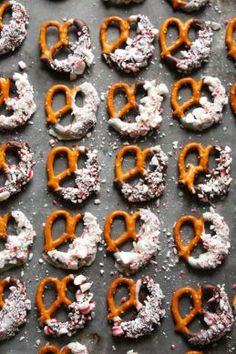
<box><xmin>100</xmin><ymin>15</ymin><xmax>158</xmax><ymax>73</ymax></box>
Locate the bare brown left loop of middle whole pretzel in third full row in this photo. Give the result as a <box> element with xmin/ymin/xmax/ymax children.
<box><xmin>115</xmin><ymin>145</ymin><xmax>151</xmax><ymax>183</ymax></box>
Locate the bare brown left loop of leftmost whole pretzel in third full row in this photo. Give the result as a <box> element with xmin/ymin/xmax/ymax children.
<box><xmin>47</xmin><ymin>146</ymin><xmax>79</xmax><ymax>191</ymax></box>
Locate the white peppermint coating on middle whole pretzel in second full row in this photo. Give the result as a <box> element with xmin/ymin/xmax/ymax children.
<box><xmin>108</xmin><ymin>80</ymin><xmax>169</xmax><ymax>138</ymax></box>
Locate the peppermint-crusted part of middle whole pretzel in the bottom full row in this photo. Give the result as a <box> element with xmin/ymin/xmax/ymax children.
<box><xmin>112</xmin><ymin>276</ymin><xmax>165</xmax><ymax>338</ymax></box>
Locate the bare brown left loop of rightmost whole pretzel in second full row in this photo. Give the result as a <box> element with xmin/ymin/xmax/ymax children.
<box><xmin>171</xmin><ymin>77</ymin><xmax>203</xmax><ymax>119</ymax></box>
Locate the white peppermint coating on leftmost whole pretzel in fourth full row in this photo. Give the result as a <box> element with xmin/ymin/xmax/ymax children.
<box><xmin>43</xmin><ymin>212</ymin><xmax>102</xmax><ymax>270</ymax></box>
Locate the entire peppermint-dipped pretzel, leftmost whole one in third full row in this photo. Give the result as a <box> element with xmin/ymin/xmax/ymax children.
<box><xmin>47</xmin><ymin>146</ymin><xmax>100</xmax><ymax>204</ymax></box>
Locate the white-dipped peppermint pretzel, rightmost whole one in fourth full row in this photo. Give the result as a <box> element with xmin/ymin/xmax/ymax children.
<box><xmin>174</xmin><ymin>209</ymin><xmax>230</xmax><ymax>269</ymax></box>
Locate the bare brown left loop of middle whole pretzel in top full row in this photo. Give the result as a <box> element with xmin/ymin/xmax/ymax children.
<box><xmin>100</xmin><ymin>16</ymin><xmax>130</xmax><ymax>53</ymax></box>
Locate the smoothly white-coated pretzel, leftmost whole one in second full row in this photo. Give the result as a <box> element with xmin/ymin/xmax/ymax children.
<box><xmin>45</xmin><ymin>82</ymin><xmax>100</xmax><ymax>140</ymax></box>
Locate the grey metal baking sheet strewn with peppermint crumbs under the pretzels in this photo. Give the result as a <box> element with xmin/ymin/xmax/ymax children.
<box><xmin>0</xmin><ymin>0</ymin><xmax>236</xmax><ymax>354</ymax></box>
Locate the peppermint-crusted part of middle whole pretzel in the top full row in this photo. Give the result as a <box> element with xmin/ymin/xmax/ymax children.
<box><xmin>103</xmin><ymin>15</ymin><xmax>158</xmax><ymax>73</ymax></box>
